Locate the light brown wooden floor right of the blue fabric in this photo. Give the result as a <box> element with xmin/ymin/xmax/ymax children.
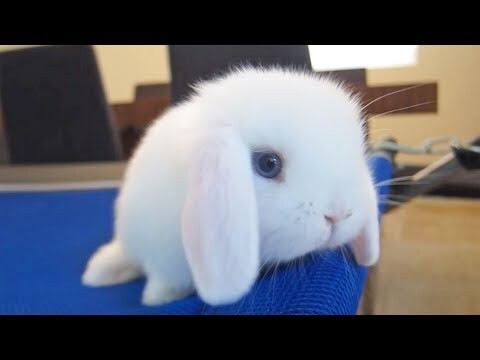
<box><xmin>359</xmin><ymin>198</ymin><xmax>480</xmax><ymax>314</ymax></box>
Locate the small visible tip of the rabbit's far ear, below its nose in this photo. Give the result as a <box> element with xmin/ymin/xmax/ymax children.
<box><xmin>351</xmin><ymin>211</ymin><xmax>380</xmax><ymax>266</ymax></box>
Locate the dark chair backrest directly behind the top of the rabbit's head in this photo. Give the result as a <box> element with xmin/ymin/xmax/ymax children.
<box><xmin>169</xmin><ymin>45</ymin><xmax>311</xmax><ymax>103</ymax></box>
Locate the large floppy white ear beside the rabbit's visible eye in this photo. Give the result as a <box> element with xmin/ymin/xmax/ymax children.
<box><xmin>182</xmin><ymin>127</ymin><xmax>260</xmax><ymax>305</ymax></box>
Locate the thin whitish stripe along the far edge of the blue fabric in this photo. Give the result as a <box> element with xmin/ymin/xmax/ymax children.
<box><xmin>0</xmin><ymin>180</ymin><xmax>121</xmax><ymax>193</ymax></box>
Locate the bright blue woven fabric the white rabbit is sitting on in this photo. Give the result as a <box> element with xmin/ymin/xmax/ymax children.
<box><xmin>0</xmin><ymin>155</ymin><xmax>392</xmax><ymax>314</ymax></box>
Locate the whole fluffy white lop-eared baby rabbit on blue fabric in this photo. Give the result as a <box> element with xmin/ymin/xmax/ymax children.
<box><xmin>82</xmin><ymin>68</ymin><xmax>379</xmax><ymax>305</ymax></box>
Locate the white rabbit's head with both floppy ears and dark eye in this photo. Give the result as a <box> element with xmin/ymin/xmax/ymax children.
<box><xmin>180</xmin><ymin>68</ymin><xmax>379</xmax><ymax>304</ymax></box>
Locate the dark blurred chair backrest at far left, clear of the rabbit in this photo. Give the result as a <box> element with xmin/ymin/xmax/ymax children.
<box><xmin>0</xmin><ymin>45</ymin><xmax>121</xmax><ymax>164</ymax></box>
